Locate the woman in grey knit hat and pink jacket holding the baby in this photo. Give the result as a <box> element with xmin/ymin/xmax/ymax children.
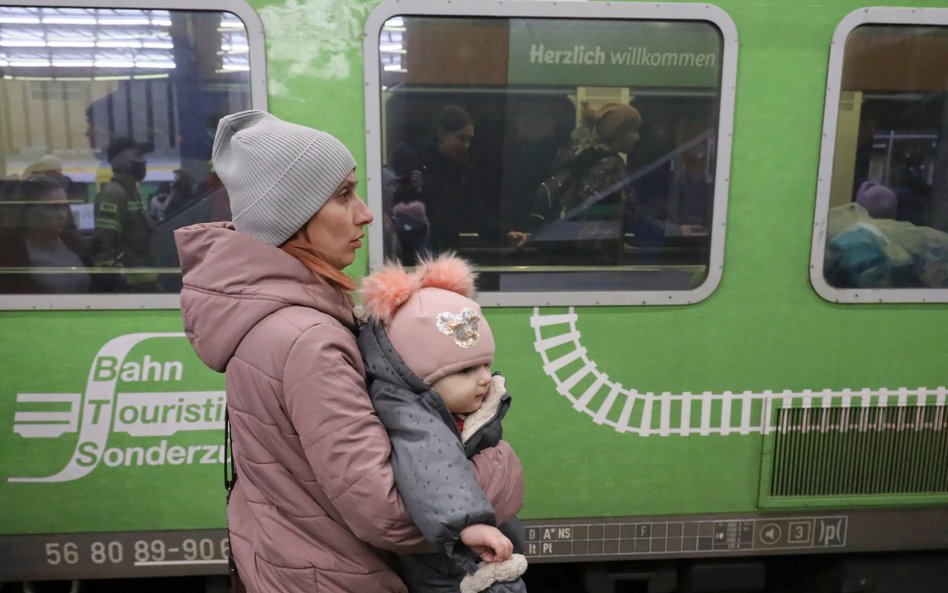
<box><xmin>175</xmin><ymin>111</ymin><xmax>523</xmax><ymax>593</ymax></box>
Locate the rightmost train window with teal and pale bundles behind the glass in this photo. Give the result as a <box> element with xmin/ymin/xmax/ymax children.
<box><xmin>810</xmin><ymin>8</ymin><xmax>948</xmax><ymax>303</ymax></box>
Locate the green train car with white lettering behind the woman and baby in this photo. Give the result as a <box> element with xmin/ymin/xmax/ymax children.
<box><xmin>0</xmin><ymin>0</ymin><xmax>948</xmax><ymax>593</ymax></box>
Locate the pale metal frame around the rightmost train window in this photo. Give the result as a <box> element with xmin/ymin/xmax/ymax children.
<box><xmin>810</xmin><ymin>7</ymin><xmax>948</xmax><ymax>304</ymax></box>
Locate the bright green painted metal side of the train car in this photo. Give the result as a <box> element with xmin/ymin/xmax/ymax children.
<box><xmin>0</xmin><ymin>0</ymin><xmax>948</xmax><ymax>556</ymax></box>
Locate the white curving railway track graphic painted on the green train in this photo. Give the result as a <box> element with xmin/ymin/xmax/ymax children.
<box><xmin>530</xmin><ymin>307</ymin><xmax>948</xmax><ymax>436</ymax></box>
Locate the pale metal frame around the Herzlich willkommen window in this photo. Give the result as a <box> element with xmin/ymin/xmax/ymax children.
<box><xmin>364</xmin><ymin>0</ymin><xmax>738</xmax><ymax>307</ymax></box>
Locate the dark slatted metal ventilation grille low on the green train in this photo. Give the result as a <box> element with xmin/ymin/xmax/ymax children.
<box><xmin>770</xmin><ymin>405</ymin><xmax>948</xmax><ymax>496</ymax></box>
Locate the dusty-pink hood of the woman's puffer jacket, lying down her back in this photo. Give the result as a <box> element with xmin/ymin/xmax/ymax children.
<box><xmin>174</xmin><ymin>222</ymin><xmax>355</xmax><ymax>372</ymax></box>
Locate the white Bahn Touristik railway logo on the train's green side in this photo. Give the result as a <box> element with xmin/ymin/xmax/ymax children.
<box><xmin>8</xmin><ymin>332</ymin><xmax>226</xmax><ymax>482</ymax></box>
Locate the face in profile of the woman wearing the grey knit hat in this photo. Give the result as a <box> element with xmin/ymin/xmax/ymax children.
<box><xmin>303</xmin><ymin>171</ymin><xmax>372</xmax><ymax>270</ymax></box>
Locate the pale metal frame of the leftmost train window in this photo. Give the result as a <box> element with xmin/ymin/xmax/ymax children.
<box><xmin>0</xmin><ymin>0</ymin><xmax>267</xmax><ymax>311</ymax></box>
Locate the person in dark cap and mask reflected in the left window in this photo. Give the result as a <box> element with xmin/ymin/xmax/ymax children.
<box><xmin>92</xmin><ymin>137</ymin><xmax>155</xmax><ymax>292</ymax></box>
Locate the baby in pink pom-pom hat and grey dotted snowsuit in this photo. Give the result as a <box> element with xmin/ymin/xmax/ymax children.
<box><xmin>359</xmin><ymin>255</ymin><xmax>527</xmax><ymax>593</ymax></box>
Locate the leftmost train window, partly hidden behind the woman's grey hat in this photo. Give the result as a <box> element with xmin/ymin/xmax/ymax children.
<box><xmin>0</xmin><ymin>0</ymin><xmax>266</xmax><ymax>309</ymax></box>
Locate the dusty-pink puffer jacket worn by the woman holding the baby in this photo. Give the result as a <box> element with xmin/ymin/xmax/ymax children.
<box><xmin>175</xmin><ymin>223</ymin><xmax>523</xmax><ymax>593</ymax></box>
